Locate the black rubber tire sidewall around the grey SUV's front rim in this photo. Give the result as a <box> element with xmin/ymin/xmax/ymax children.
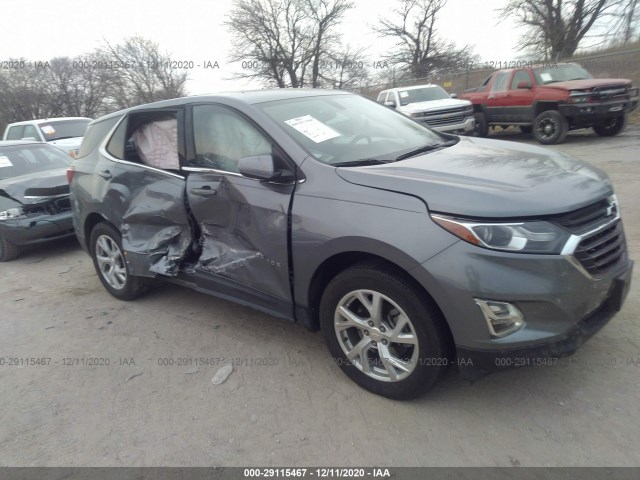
<box><xmin>320</xmin><ymin>268</ymin><xmax>451</xmax><ymax>400</ymax></box>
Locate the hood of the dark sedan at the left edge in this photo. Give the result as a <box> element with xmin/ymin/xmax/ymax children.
<box><xmin>0</xmin><ymin>168</ymin><xmax>69</xmax><ymax>205</ymax></box>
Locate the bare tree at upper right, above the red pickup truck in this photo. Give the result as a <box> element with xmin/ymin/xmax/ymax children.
<box><xmin>501</xmin><ymin>0</ymin><xmax>619</xmax><ymax>61</ymax></box>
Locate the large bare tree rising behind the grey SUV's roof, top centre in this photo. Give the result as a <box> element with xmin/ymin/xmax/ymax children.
<box><xmin>225</xmin><ymin>0</ymin><xmax>353</xmax><ymax>88</ymax></box>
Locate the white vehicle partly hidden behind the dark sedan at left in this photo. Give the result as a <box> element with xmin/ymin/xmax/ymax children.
<box><xmin>3</xmin><ymin>117</ymin><xmax>91</xmax><ymax>157</ymax></box>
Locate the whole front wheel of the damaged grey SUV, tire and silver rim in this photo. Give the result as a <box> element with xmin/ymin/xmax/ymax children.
<box><xmin>320</xmin><ymin>263</ymin><xmax>452</xmax><ymax>400</ymax></box>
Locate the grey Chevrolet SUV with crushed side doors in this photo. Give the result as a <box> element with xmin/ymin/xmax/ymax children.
<box><xmin>69</xmin><ymin>89</ymin><xmax>632</xmax><ymax>399</ymax></box>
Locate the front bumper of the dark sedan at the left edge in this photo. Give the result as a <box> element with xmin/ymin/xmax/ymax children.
<box><xmin>0</xmin><ymin>211</ymin><xmax>74</xmax><ymax>246</ymax></box>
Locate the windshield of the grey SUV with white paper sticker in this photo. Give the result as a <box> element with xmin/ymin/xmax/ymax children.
<box><xmin>257</xmin><ymin>95</ymin><xmax>446</xmax><ymax>164</ymax></box>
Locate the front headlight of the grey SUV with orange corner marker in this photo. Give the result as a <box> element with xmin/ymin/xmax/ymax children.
<box><xmin>431</xmin><ymin>214</ymin><xmax>571</xmax><ymax>254</ymax></box>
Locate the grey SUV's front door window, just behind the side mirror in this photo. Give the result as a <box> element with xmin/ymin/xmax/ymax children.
<box><xmin>190</xmin><ymin>105</ymin><xmax>272</xmax><ymax>172</ymax></box>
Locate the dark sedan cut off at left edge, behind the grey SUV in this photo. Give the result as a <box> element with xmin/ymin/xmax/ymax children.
<box><xmin>0</xmin><ymin>141</ymin><xmax>74</xmax><ymax>262</ymax></box>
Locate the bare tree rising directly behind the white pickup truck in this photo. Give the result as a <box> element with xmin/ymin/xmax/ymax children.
<box><xmin>375</xmin><ymin>0</ymin><xmax>475</xmax><ymax>78</ymax></box>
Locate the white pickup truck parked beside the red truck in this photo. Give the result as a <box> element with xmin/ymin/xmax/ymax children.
<box><xmin>378</xmin><ymin>84</ymin><xmax>475</xmax><ymax>134</ymax></box>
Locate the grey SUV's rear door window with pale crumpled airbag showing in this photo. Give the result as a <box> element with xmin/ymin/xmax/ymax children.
<box><xmin>106</xmin><ymin>111</ymin><xmax>180</xmax><ymax>170</ymax></box>
